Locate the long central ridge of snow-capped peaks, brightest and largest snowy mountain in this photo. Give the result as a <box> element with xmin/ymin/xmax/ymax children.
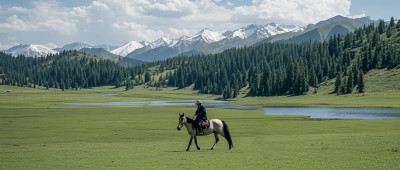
<box><xmin>126</xmin><ymin>23</ymin><xmax>302</xmax><ymax>61</ymax></box>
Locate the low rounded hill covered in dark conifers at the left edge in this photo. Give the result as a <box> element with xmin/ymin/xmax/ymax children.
<box><xmin>0</xmin><ymin>51</ymin><xmax>133</xmax><ymax>90</ymax></box>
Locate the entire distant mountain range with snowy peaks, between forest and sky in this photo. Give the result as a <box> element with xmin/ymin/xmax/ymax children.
<box><xmin>5</xmin><ymin>16</ymin><xmax>377</xmax><ymax>62</ymax></box>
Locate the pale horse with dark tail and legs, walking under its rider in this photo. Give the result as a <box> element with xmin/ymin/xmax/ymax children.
<box><xmin>176</xmin><ymin>113</ymin><xmax>233</xmax><ymax>151</ymax></box>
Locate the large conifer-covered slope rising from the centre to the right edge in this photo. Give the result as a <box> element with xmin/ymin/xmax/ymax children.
<box><xmin>136</xmin><ymin>18</ymin><xmax>400</xmax><ymax>98</ymax></box>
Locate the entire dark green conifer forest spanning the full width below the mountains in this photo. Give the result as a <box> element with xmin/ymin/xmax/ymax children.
<box><xmin>0</xmin><ymin>18</ymin><xmax>400</xmax><ymax>99</ymax></box>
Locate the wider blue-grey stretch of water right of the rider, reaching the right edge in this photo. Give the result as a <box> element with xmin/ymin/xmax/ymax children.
<box><xmin>264</xmin><ymin>107</ymin><xmax>400</xmax><ymax>119</ymax></box>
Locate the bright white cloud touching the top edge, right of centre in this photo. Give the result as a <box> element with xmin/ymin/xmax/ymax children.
<box><xmin>235</xmin><ymin>0</ymin><xmax>351</xmax><ymax>24</ymax></box>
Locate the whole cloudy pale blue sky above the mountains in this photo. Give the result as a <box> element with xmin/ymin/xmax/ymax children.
<box><xmin>0</xmin><ymin>0</ymin><xmax>400</xmax><ymax>50</ymax></box>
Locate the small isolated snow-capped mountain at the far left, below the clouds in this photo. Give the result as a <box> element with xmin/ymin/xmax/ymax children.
<box><xmin>4</xmin><ymin>44</ymin><xmax>58</xmax><ymax>57</ymax></box>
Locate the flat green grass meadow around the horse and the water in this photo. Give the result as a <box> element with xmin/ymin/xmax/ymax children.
<box><xmin>0</xmin><ymin>83</ymin><xmax>400</xmax><ymax>169</ymax></box>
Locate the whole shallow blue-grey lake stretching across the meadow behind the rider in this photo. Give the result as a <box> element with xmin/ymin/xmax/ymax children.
<box><xmin>62</xmin><ymin>100</ymin><xmax>400</xmax><ymax>119</ymax></box>
